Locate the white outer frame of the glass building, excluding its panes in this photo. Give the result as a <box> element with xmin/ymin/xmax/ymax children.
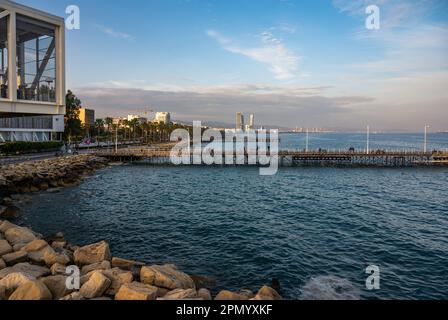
<box><xmin>0</xmin><ymin>0</ymin><xmax>65</xmax><ymax>142</ymax></box>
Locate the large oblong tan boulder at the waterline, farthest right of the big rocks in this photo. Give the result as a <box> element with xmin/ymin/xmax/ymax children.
<box><xmin>140</xmin><ymin>265</ymin><xmax>195</xmax><ymax>290</ymax></box>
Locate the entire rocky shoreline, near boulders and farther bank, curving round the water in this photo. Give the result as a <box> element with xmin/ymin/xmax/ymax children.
<box><xmin>0</xmin><ymin>155</ymin><xmax>282</xmax><ymax>300</ymax></box>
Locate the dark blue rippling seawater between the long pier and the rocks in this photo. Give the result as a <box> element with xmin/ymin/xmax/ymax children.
<box><xmin>16</xmin><ymin>135</ymin><xmax>448</xmax><ymax>299</ymax></box>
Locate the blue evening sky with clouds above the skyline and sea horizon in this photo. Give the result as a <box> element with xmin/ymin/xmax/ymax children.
<box><xmin>18</xmin><ymin>0</ymin><xmax>448</xmax><ymax>132</ymax></box>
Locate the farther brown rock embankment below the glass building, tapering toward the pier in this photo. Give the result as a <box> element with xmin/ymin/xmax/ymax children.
<box><xmin>0</xmin><ymin>155</ymin><xmax>108</xmax><ymax>218</ymax></box>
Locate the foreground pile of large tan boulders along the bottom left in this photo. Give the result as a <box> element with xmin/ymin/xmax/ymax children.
<box><xmin>0</xmin><ymin>221</ymin><xmax>281</xmax><ymax>300</ymax></box>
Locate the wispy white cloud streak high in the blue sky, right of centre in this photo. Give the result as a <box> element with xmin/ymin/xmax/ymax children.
<box><xmin>206</xmin><ymin>30</ymin><xmax>300</xmax><ymax>80</ymax></box>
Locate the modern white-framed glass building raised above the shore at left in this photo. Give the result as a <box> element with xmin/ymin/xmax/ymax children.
<box><xmin>0</xmin><ymin>0</ymin><xmax>65</xmax><ymax>142</ymax></box>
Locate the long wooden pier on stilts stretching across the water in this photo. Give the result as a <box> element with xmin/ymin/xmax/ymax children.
<box><xmin>94</xmin><ymin>147</ymin><xmax>448</xmax><ymax>167</ymax></box>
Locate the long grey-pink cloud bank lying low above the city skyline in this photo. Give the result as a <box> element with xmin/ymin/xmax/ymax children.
<box><xmin>74</xmin><ymin>84</ymin><xmax>373</xmax><ymax>131</ymax></box>
